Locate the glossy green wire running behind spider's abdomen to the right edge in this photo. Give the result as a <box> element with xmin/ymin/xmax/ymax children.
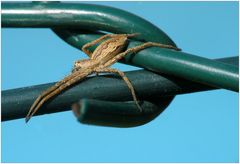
<box><xmin>54</xmin><ymin>29</ymin><xmax>239</xmax><ymax>92</ymax></box>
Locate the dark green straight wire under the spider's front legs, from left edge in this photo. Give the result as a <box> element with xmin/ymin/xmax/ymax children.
<box><xmin>2</xmin><ymin>57</ymin><xmax>238</xmax><ymax>121</ymax></box>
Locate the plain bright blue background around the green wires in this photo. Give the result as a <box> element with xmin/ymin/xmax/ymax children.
<box><xmin>2</xmin><ymin>2</ymin><xmax>238</xmax><ymax>162</ymax></box>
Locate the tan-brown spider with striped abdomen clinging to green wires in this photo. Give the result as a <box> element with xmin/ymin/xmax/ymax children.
<box><xmin>25</xmin><ymin>33</ymin><xmax>180</xmax><ymax>122</ymax></box>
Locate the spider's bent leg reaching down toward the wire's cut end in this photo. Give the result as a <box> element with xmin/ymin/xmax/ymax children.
<box><xmin>95</xmin><ymin>68</ymin><xmax>142</xmax><ymax>111</ymax></box>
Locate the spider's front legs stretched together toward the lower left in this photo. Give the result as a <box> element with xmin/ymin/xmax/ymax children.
<box><xmin>26</xmin><ymin>69</ymin><xmax>92</xmax><ymax>122</ymax></box>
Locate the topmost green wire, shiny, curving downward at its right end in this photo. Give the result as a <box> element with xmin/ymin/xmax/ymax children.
<box><xmin>1</xmin><ymin>2</ymin><xmax>176</xmax><ymax>46</ymax></box>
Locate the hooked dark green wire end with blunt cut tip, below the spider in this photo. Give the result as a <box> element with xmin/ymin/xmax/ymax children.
<box><xmin>73</xmin><ymin>97</ymin><xmax>174</xmax><ymax>128</ymax></box>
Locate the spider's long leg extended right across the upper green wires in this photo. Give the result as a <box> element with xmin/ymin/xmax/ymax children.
<box><xmin>103</xmin><ymin>42</ymin><xmax>181</xmax><ymax>67</ymax></box>
